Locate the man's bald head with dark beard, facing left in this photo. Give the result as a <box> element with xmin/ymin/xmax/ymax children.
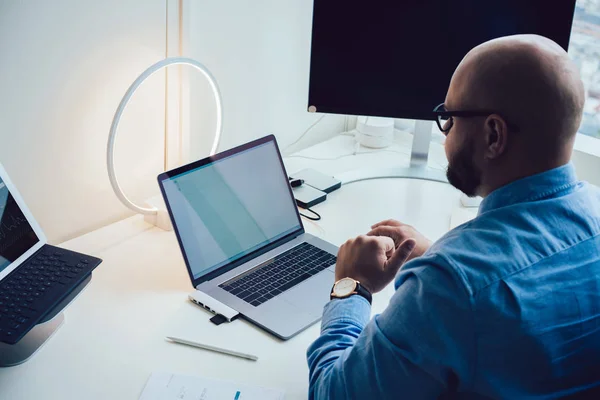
<box><xmin>445</xmin><ymin>35</ymin><xmax>585</xmax><ymax>196</ymax></box>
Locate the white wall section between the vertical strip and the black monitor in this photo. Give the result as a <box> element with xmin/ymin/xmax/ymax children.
<box><xmin>184</xmin><ymin>0</ymin><xmax>344</xmax><ymax>159</ymax></box>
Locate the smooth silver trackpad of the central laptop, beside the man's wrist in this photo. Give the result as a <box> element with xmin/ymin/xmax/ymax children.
<box><xmin>284</xmin><ymin>269</ymin><xmax>335</xmax><ymax>317</ymax></box>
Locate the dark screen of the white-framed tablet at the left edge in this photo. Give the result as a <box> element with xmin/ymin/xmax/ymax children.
<box><xmin>0</xmin><ymin>178</ymin><xmax>39</xmax><ymax>277</ymax></box>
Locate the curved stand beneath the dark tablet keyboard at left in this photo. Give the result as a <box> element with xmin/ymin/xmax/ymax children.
<box><xmin>0</xmin><ymin>273</ymin><xmax>92</xmax><ymax>367</ymax></box>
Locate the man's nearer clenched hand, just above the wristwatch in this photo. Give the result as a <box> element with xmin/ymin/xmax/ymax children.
<box><xmin>335</xmin><ymin>235</ymin><xmax>416</xmax><ymax>293</ymax></box>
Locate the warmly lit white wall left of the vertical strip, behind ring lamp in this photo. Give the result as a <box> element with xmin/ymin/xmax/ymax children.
<box><xmin>0</xmin><ymin>0</ymin><xmax>166</xmax><ymax>243</ymax></box>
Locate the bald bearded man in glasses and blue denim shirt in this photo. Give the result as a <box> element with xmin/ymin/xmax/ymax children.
<box><xmin>308</xmin><ymin>35</ymin><xmax>600</xmax><ymax>399</ymax></box>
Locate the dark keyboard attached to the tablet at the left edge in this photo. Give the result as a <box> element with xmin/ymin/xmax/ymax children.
<box><xmin>0</xmin><ymin>245</ymin><xmax>101</xmax><ymax>344</ymax></box>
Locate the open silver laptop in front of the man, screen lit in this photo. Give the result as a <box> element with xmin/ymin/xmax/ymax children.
<box><xmin>158</xmin><ymin>135</ymin><xmax>338</xmax><ymax>339</ymax></box>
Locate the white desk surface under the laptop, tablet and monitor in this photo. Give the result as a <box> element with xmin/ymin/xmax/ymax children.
<box><xmin>0</xmin><ymin>133</ymin><xmax>476</xmax><ymax>400</ymax></box>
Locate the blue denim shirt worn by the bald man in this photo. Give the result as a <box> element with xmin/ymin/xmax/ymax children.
<box><xmin>307</xmin><ymin>163</ymin><xmax>600</xmax><ymax>399</ymax></box>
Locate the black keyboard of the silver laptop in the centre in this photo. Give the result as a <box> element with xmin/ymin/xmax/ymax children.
<box><xmin>219</xmin><ymin>243</ymin><xmax>336</xmax><ymax>306</ymax></box>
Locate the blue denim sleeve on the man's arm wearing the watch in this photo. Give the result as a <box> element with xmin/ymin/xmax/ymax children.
<box><xmin>307</xmin><ymin>255</ymin><xmax>475</xmax><ymax>399</ymax></box>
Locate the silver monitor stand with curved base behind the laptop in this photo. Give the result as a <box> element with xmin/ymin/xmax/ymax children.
<box><xmin>336</xmin><ymin>120</ymin><xmax>448</xmax><ymax>185</ymax></box>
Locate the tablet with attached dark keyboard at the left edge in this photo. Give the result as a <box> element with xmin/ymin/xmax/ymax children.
<box><xmin>0</xmin><ymin>165</ymin><xmax>102</xmax><ymax>344</ymax></box>
